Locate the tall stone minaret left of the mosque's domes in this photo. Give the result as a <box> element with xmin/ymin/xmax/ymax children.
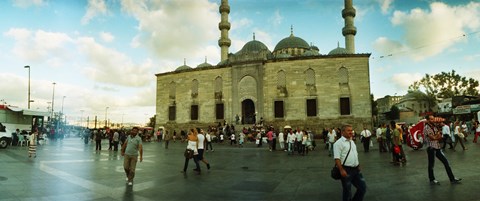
<box><xmin>218</xmin><ymin>0</ymin><xmax>232</xmax><ymax>61</ymax></box>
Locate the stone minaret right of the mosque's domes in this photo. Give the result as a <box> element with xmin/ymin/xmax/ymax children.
<box><xmin>342</xmin><ymin>0</ymin><xmax>357</xmax><ymax>54</ymax></box>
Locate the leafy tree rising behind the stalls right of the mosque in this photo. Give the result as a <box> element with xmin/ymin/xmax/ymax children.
<box><xmin>408</xmin><ymin>70</ymin><xmax>479</xmax><ymax>100</ymax></box>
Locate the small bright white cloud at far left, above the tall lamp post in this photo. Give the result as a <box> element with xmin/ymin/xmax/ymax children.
<box><xmin>4</xmin><ymin>28</ymin><xmax>74</xmax><ymax>62</ymax></box>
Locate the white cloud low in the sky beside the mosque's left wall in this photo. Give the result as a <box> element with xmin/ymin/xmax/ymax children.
<box><xmin>78</xmin><ymin>37</ymin><xmax>154</xmax><ymax>87</ymax></box>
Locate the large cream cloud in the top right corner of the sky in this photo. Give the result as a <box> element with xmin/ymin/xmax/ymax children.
<box><xmin>377</xmin><ymin>2</ymin><xmax>480</xmax><ymax>60</ymax></box>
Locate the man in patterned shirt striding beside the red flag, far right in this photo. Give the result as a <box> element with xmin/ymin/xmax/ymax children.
<box><xmin>423</xmin><ymin>115</ymin><xmax>462</xmax><ymax>185</ymax></box>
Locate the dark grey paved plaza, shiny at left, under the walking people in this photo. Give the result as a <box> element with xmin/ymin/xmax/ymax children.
<box><xmin>0</xmin><ymin>138</ymin><xmax>480</xmax><ymax>201</ymax></box>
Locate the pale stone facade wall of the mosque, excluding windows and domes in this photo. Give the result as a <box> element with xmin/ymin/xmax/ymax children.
<box><xmin>156</xmin><ymin>54</ymin><xmax>372</xmax><ymax>131</ymax></box>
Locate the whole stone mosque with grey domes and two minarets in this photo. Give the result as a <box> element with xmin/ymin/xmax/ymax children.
<box><xmin>156</xmin><ymin>0</ymin><xmax>372</xmax><ymax>133</ymax></box>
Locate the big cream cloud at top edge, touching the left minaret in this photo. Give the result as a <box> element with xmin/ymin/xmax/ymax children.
<box><xmin>121</xmin><ymin>0</ymin><xmax>220</xmax><ymax>64</ymax></box>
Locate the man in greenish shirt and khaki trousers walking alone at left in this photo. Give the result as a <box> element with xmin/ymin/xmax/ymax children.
<box><xmin>122</xmin><ymin>127</ymin><xmax>143</xmax><ymax>186</ymax></box>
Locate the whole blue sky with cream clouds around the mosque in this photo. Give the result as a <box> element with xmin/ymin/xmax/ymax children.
<box><xmin>0</xmin><ymin>0</ymin><xmax>480</xmax><ymax>123</ymax></box>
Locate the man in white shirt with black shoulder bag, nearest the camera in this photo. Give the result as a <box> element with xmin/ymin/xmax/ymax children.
<box><xmin>333</xmin><ymin>124</ymin><xmax>367</xmax><ymax>201</ymax></box>
